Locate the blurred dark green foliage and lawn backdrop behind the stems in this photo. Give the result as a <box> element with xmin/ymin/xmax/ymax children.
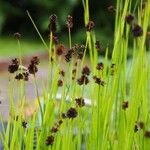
<box><xmin>0</xmin><ymin>0</ymin><xmax>141</xmax><ymax>56</ymax></box>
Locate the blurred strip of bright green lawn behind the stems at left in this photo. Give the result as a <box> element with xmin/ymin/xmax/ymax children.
<box><xmin>0</xmin><ymin>37</ymin><xmax>45</xmax><ymax>57</ymax></box>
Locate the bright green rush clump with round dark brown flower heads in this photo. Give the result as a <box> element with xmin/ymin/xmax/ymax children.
<box><xmin>0</xmin><ymin>0</ymin><xmax>150</xmax><ymax>150</ymax></box>
